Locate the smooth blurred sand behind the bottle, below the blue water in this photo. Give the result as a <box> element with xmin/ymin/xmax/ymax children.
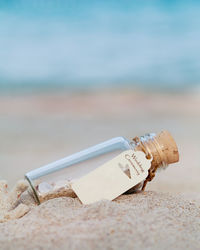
<box><xmin>0</xmin><ymin>90</ymin><xmax>200</xmax><ymax>194</ymax></box>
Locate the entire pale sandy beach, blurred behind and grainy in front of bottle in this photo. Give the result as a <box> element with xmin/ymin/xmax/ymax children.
<box><xmin>0</xmin><ymin>90</ymin><xmax>200</xmax><ymax>249</ymax></box>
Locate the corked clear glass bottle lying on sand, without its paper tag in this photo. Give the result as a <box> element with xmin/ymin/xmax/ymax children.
<box><xmin>25</xmin><ymin>131</ymin><xmax>179</xmax><ymax>204</ymax></box>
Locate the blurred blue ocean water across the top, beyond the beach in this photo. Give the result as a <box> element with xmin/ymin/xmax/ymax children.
<box><xmin>0</xmin><ymin>0</ymin><xmax>200</xmax><ymax>91</ymax></box>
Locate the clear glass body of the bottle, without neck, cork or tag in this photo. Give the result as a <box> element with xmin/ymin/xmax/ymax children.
<box><xmin>25</xmin><ymin>137</ymin><xmax>134</xmax><ymax>203</ymax></box>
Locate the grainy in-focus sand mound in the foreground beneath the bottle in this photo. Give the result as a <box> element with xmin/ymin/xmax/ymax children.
<box><xmin>0</xmin><ymin>192</ymin><xmax>200</xmax><ymax>250</ymax></box>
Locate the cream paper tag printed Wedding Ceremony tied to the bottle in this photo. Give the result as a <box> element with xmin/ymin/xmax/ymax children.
<box><xmin>71</xmin><ymin>150</ymin><xmax>151</xmax><ymax>204</ymax></box>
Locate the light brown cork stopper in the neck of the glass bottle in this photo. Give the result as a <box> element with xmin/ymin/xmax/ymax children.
<box><xmin>136</xmin><ymin>130</ymin><xmax>179</xmax><ymax>167</ymax></box>
